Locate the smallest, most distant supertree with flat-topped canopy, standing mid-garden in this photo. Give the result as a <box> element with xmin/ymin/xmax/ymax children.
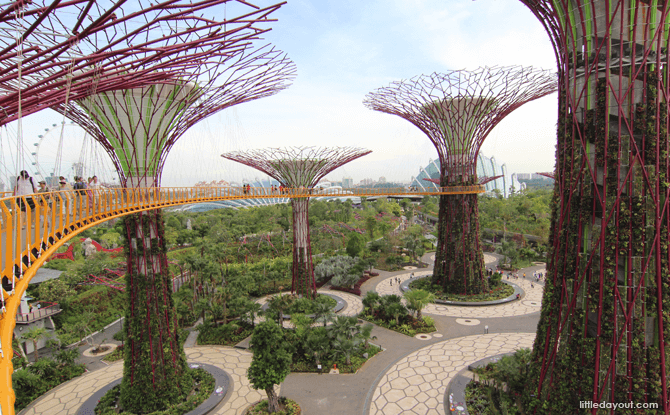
<box><xmin>221</xmin><ymin>147</ymin><xmax>371</xmax><ymax>298</ymax></box>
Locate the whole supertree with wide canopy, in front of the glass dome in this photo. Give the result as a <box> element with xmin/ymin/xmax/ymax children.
<box><xmin>363</xmin><ymin>66</ymin><xmax>556</xmax><ymax>294</ymax></box>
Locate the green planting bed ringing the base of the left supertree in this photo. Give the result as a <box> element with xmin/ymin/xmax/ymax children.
<box><xmin>95</xmin><ymin>369</ymin><xmax>216</xmax><ymax>415</ymax></box>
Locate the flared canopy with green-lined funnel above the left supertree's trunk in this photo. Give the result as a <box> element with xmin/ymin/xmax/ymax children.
<box><xmin>57</xmin><ymin>44</ymin><xmax>296</xmax><ymax>187</ymax></box>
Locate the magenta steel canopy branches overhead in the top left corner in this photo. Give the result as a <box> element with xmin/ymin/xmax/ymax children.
<box><xmin>0</xmin><ymin>0</ymin><xmax>252</xmax><ymax>125</ymax></box>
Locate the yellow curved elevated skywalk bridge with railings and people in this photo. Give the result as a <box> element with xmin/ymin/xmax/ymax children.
<box><xmin>0</xmin><ymin>185</ymin><xmax>484</xmax><ymax>415</ymax></box>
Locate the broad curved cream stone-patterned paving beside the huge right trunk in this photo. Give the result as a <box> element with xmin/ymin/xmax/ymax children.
<box><xmin>369</xmin><ymin>333</ymin><xmax>535</xmax><ymax>415</ymax></box>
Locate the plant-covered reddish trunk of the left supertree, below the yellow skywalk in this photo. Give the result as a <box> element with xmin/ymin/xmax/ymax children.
<box><xmin>121</xmin><ymin>210</ymin><xmax>192</xmax><ymax>413</ymax></box>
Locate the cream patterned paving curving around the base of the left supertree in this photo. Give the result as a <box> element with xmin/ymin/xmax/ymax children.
<box><xmin>22</xmin><ymin>346</ymin><xmax>265</xmax><ymax>415</ymax></box>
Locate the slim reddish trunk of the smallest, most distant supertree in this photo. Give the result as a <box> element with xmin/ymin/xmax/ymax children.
<box><xmin>291</xmin><ymin>198</ymin><xmax>316</xmax><ymax>298</ymax></box>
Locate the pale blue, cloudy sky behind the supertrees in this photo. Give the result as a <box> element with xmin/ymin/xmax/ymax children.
<box><xmin>0</xmin><ymin>0</ymin><xmax>558</xmax><ymax>186</ymax></box>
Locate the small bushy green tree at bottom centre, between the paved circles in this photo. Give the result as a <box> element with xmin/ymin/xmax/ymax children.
<box><xmin>247</xmin><ymin>321</ymin><xmax>291</xmax><ymax>413</ymax></box>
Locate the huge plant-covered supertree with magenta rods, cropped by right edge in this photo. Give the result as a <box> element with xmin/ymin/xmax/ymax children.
<box><xmin>522</xmin><ymin>0</ymin><xmax>670</xmax><ymax>414</ymax></box>
